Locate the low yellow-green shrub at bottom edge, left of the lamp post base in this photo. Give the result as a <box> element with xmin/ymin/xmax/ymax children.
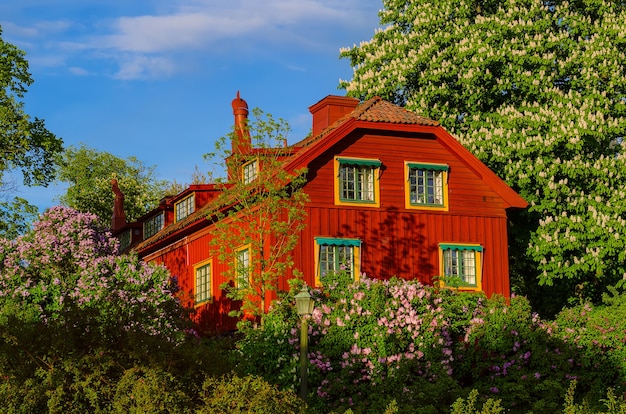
<box><xmin>196</xmin><ymin>375</ymin><xmax>305</xmax><ymax>414</ymax></box>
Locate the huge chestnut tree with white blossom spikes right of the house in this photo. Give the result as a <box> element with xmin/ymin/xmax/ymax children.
<box><xmin>340</xmin><ymin>0</ymin><xmax>626</xmax><ymax>310</ymax></box>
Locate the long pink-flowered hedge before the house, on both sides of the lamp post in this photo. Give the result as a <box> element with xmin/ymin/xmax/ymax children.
<box><xmin>239</xmin><ymin>274</ymin><xmax>624</xmax><ymax>413</ymax></box>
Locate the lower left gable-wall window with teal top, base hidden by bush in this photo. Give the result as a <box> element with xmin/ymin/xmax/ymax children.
<box><xmin>315</xmin><ymin>237</ymin><xmax>361</xmax><ymax>286</ymax></box>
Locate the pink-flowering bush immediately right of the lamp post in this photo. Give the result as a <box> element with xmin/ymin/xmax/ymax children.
<box><xmin>290</xmin><ymin>278</ymin><xmax>454</xmax><ymax>401</ymax></box>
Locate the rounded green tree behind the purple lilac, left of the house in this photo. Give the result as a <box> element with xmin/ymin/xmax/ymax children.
<box><xmin>57</xmin><ymin>145</ymin><xmax>167</xmax><ymax>226</ymax></box>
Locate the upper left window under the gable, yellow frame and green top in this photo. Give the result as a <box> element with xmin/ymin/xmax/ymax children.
<box><xmin>335</xmin><ymin>157</ymin><xmax>381</xmax><ymax>207</ymax></box>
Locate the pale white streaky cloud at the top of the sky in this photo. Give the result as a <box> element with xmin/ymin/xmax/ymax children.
<box><xmin>100</xmin><ymin>0</ymin><xmax>366</xmax><ymax>53</ymax></box>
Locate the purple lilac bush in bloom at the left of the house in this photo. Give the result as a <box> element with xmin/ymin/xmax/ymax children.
<box><xmin>0</xmin><ymin>207</ymin><xmax>184</xmax><ymax>341</ymax></box>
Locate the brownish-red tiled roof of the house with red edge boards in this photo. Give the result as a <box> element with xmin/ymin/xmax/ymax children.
<box><xmin>134</xmin><ymin>97</ymin><xmax>528</xmax><ymax>256</ymax></box>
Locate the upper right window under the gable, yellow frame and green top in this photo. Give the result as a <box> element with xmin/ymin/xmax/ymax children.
<box><xmin>405</xmin><ymin>162</ymin><xmax>448</xmax><ymax>211</ymax></box>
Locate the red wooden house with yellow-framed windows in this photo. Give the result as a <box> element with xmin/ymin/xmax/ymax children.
<box><xmin>113</xmin><ymin>96</ymin><xmax>527</xmax><ymax>331</ymax></box>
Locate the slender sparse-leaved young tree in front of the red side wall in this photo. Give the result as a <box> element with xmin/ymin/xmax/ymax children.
<box><xmin>205</xmin><ymin>108</ymin><xmax>308</xmax><ymax>316</ymax></box>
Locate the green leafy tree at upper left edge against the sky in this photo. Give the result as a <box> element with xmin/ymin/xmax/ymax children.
<box><xmin>0</xmin><ymin>27</ymin><xmax>63</xmax><ymax>188</ymax></box>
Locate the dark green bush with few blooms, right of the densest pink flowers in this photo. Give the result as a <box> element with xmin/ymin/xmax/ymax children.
<box><xmin>455</xmin><ymin>297</ymin><xmax>581</xmax><ymax>413</ymax></box>
